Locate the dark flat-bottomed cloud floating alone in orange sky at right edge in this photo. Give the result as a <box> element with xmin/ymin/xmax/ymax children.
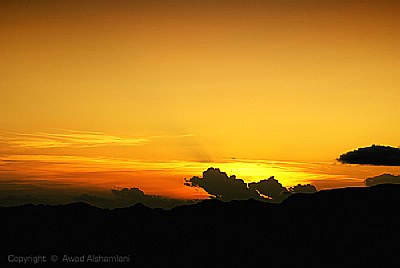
<box><xmin>338</xmin><ymin>145</ymin><xmax>400</xmax><ymax>166</ymax></box>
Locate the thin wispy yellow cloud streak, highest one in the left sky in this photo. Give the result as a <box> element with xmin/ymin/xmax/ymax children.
<box><xmin>0</xmin><ymin>130</ymin><xmax>156</xmax><ymax>149</ymax></box>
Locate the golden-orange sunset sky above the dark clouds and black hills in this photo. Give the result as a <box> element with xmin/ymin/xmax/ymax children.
<box><xmin>0</xmin><ymin>0</ymin><xmax>400</xmax><ymax>202</ymax></box>
